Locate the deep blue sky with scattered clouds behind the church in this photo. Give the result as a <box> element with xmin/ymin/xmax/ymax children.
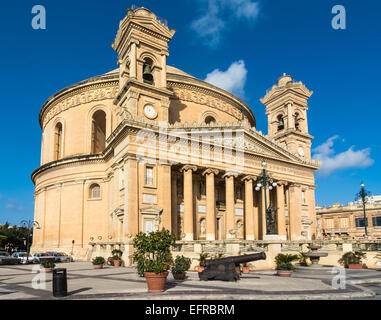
<box><xmin>0</xmin><ymin>0</ymin><xmax>381</xmax><ymax>224</ymax></box>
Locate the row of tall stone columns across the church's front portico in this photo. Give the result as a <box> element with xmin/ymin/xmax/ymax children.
<box><xmin>181</xmin><ymin>165</ymin><xmax>302</xmax><ymax>240</ymax></box>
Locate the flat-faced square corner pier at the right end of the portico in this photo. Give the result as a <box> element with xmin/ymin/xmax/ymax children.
<box><xmin>288</xmin><ymin>184</ymin><xmax>302</xmax><ymax>240</ymax></box>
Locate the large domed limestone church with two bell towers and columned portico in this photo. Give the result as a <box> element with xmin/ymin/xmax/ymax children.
<box><xmin>32</xmin><ymin>8</ymin><xmax>319</xmax><ymax>259</ymax></box>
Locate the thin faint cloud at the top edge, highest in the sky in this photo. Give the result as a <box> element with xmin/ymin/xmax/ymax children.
<box><xmin>191</xmin><ymin>0</ymin><xmax>259</xmax><ymax>47</ymax></box>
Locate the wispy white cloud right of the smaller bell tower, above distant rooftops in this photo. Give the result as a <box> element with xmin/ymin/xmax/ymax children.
<box><xmin>312</xmin><ymin>135</ymin><xmax>374</xmax><ymax>176</ymax></box>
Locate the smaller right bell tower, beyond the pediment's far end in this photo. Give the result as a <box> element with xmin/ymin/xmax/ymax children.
<box><xmin>261</xmin><ymin>74</ymin><xmax>313</xmax><ymax>159</ymax></box>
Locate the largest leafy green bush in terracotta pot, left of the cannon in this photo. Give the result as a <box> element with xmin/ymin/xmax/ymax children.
<box><xmin>133</xmin><ymin>230</ymin><xmax>176</xmax><ymax>292</ymax></box>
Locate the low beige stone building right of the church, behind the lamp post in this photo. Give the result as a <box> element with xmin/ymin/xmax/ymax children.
<box><xmin>316</xmin><ymin>196</ymin><xmax>381</xmax><ymax>240</ymax></box>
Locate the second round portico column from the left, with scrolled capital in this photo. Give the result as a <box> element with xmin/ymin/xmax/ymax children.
<box><xmin>202</xmin><ymin>168</ymin><xmax>219</xmax><ymax>240</ymax></box>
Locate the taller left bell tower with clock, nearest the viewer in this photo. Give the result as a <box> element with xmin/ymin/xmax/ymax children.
<box><xmin>112</xmin><ymin>8</ymin><xmax>175</xmax><ymax>124</ymax></box>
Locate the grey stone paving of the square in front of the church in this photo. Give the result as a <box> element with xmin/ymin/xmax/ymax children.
<box><xmin>0</xmin><ymin>262</ymin><xmax>381</xmax><ymax>300</ymax></box>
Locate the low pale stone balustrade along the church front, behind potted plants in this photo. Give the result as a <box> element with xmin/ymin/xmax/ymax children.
<box><xmin>87</xmin><ymin>240</ymin><xmax>381</xmax><ymax>270</ymax></box>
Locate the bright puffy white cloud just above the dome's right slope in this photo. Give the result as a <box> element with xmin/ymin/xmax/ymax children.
<box><xmin>205</xmin><ymin>60</ymin><xmax>247</xmax><ymax>97</ymax></box>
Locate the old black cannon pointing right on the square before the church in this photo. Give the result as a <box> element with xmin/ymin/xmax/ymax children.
<box><xmin>198</xmin><ymin>252</ymin><xmax>266</xmax><ymax>281</ymax></box>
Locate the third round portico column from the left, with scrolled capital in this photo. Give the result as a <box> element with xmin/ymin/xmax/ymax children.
<box><xmin>224</xmin><ymin>172</ymin><xmax>238</xmax><ymax>240</ymax></box>
